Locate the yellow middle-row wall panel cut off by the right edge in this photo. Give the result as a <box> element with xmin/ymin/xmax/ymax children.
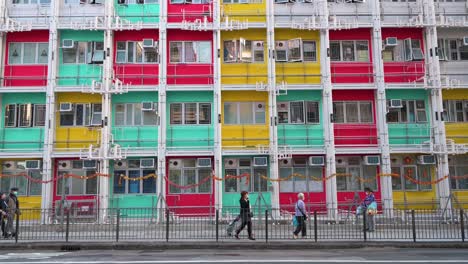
<box><xmin>442</xmin><ymin>89</ymin><xmax>468</xmax><ymax>144</ymax></box>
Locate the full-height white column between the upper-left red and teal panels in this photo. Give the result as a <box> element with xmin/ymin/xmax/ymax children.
<box><xmin>41</xmin><ymin>0</ymin><xmax>60</xmax><ymax>224</ymax></box>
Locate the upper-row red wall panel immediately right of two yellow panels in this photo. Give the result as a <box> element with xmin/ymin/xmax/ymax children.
<box><xmin>330</xmin><ymin>28</ymin><xmax>374</xmax><ymax>83</ymax></box>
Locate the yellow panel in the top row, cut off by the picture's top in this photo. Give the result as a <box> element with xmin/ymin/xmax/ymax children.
<box><xmin>221</xmin><ymin>0</ymin><xmax>270</xmax><ymax>23</ymax></box>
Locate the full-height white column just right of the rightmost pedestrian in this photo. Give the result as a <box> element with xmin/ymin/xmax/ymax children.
<box><xmin>370</xmin><ymin>1</ymin><xmax>393</xmax><ymax>212</ymax></box>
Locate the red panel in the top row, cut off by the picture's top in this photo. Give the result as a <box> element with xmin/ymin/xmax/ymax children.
<box><xmin>167</xmin><ymin>0</ymin><xmax>213</xmax><ymax>23</ymax></box>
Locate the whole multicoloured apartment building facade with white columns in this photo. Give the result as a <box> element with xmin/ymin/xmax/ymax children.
<box><xmin>0</xmin><ymin>0</ymin><xmax>468</xmax><ymax>221</ymax></box>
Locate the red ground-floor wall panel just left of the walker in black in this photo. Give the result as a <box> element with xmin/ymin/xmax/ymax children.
<box><xmin>166</xmin><ymin>157</ymin><xmax>216</xmax><ymax>216</ymax></box>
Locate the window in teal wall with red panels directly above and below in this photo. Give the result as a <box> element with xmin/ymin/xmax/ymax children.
<box><xmin>170</xmin><ymin>103</ymin><xmax>211</xmax><ymax>125</ymax></box>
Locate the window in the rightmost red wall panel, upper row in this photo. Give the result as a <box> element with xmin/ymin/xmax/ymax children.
<box><xmin>382</xmin><ymin>38</ymin><xmax>424</xmax><ymax>62</ymax></box>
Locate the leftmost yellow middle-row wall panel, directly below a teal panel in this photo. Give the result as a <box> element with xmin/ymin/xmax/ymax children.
<box><xmin>55</xmin><ymin>93</ymin><xmax>101</xmax><ymax>149</ymax></box>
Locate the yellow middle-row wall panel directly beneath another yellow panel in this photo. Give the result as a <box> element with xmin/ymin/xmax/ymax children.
<box><xmin>221</xmin><ymin>91</ymin><xmax>269</xmax><ymax>147</ymax></box>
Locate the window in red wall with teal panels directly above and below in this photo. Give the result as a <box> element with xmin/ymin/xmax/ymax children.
<box><xmin>115</xmin><ymin>41</ymin><xmax>159</xmax><ymax>64</ymax></box>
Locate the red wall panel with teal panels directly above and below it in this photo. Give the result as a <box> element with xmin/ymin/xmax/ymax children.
<box><xmin>114</xmin><ymin>29</ymin><xmax>159</xmax><ymax>85</ymax></box>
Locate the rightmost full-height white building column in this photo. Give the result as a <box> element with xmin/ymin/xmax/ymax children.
<box><xmin>423</xmin><ymin>0</ymin><xmax>452</xmax><ymax>215</ymax></box>
